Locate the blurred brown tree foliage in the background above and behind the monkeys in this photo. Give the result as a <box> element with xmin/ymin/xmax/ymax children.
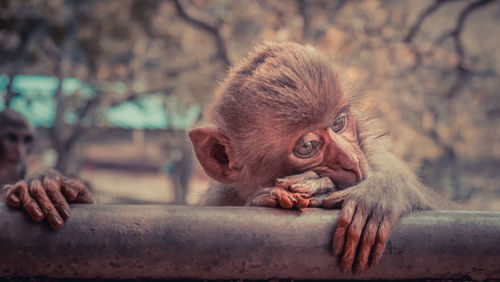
<box><xmin>0</xmin><ymin>0</ymin><xmax>500</xmax><ymax>207</ymax></box>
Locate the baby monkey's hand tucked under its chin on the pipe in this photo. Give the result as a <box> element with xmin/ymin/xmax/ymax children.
<box><xmin>275</xmin><ymin>171</ymin><xmax>335</xmax><ymax>207</ymax></box>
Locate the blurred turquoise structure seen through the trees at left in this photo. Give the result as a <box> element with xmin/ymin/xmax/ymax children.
<box><xmin>0</xmin><ymin>75</ymin><xmax>201</xmax><ymax>129</ymax></box>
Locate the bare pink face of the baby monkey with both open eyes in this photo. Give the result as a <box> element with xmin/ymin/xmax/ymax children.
<box><xmin>286</xmin><ymin>111</ymin><xmax>365</xmax><ymax>189</ymax></box>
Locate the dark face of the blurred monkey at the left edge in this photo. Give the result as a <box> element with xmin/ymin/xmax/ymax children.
<box><xmin>0</xmin><ymin>128</ymin><xmax>33</xmax><ymax>164</ymax></box>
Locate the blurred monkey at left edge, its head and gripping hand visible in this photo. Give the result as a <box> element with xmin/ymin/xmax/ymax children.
<box><xmin>0</xmin><ymin>109</ymin><xmax>93</xmax><ymax>229</ymax></box>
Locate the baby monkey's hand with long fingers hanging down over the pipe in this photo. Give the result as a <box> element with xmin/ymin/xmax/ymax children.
<box><xmin>322</xmin><ymin>176</ymin><xmax>407</xmax><ymax>273</ymax></box>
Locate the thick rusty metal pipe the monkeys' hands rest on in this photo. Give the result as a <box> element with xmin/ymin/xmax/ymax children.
<box><xmin>0</xmin><ymin>204</ymin><xmax>500</xmax><ymax>280</ymax></box>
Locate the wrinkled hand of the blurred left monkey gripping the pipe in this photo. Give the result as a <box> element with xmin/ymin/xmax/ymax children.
<box><xmin>4</xmin><ymin>170</ymin><xmax>93</xmax><ymax>229</ymax></box>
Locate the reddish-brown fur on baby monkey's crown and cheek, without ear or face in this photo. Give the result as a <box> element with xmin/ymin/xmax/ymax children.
<box><xmin>206</xmin><ymin>43</ymin><xmax>347</xmax><ymax>198</ymax></box>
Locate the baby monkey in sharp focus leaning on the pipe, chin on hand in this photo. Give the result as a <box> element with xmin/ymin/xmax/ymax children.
<box><xmin>189</xmin><ymin>43</ymin><xmax>442</xmax><ymax>272</ymax></box>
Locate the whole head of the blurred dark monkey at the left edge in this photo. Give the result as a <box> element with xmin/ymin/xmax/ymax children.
<box><xmin>0</xmin><ymin>109</ymin><xmax>34</xmax><ymax>165</ymax></box>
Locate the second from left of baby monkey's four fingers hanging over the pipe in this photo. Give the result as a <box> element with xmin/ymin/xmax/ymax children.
<box><xmin>340</xmin><ymin>205</ymin><xmax>367</xmax><ymax>272</ymax></box>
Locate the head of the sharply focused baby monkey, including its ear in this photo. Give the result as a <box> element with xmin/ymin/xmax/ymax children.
<box><xmin>189</xmin><ymin>43</ymin><xmax>366</xmax><ymax>194</ymax></box>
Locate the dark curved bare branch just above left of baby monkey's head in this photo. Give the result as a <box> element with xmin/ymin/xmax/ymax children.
<box><xmin>173</xmin><ymin>0</ymin><xmax>231</xmax><ymax>67</ymax></box>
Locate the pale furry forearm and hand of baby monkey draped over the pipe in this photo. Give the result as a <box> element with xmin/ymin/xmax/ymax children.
<box><xmin>322</xmin><ymin>152</ymin><xmax>444</xmax><ymax>272</ymax></box>
